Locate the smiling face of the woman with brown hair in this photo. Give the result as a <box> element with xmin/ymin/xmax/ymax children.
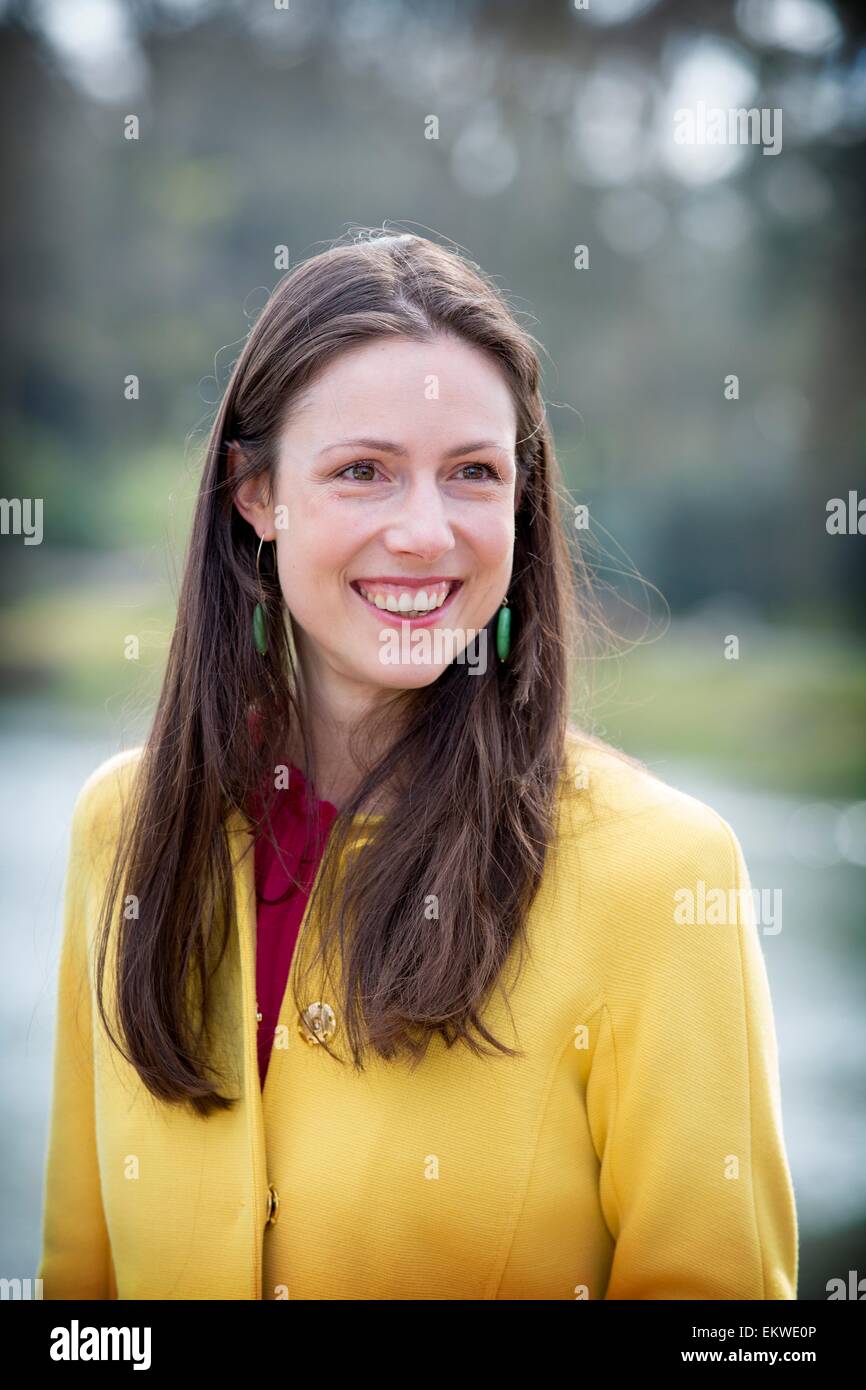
<box><xmin>237</xmin><ymin>336</ymin><xmax>517</xmax><ymax>700</ymax></box>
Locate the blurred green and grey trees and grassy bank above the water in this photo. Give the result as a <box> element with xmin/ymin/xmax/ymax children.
<box><xmin>0</xmin><ymin>0</ymin><xmax>866</xmax><ymax>795</ymax></box>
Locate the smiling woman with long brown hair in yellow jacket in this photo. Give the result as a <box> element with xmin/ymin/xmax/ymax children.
<box><xmin>39</xmin><ymin>236</ymin><xmax>798</xmax><ymax>1300</ymax></box>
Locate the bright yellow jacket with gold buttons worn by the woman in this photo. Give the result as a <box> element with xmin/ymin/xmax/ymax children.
<box><xmin>38</xmin><ymin>734</ymin><xmax>798</xmax><ymax>1300</ymax></box>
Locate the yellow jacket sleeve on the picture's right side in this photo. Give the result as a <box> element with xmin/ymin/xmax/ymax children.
<box><xmin>588</xmin><ymin>803</ymin><xmax>798</xmax><ymax>1300</ymax></box>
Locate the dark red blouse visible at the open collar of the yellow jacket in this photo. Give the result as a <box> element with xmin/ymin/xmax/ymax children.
<box><xmin>256</xmin><ymin>763</ymin><xmax>339</xmax><ymax>1088</ymax></box>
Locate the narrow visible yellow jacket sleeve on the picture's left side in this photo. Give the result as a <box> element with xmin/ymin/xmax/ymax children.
<box><xmin>38</xmin><ymin>784</ymin><xmax>117</xmax><ymax>1300</ymax></box>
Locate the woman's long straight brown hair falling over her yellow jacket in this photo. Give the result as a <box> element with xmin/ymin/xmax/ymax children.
<box><xmin>97</xmin><ymin>229</ymin><xmax>594</xmax><ymax>1115</ymax></box>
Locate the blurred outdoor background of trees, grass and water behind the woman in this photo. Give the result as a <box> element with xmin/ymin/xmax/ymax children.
<box><xmin>0</xmin><ymin>0</ymin><xmax>866</xmax><ymax>1298</ymax></box>
